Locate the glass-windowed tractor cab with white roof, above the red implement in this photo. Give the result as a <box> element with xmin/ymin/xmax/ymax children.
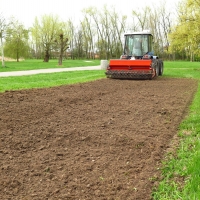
<box><xmin>121</xmin><ymin>32</ymin><xmax>153</xmax><ymax>59</ymax></box>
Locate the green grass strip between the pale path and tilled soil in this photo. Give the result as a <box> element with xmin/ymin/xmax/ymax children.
<box><xmin>0</xmin><ymin>70</ymin><xmax>105</xmax><ymax>92</ymax></box>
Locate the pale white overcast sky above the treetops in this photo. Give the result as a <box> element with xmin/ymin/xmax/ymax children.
<box><xmin>0</xmin><ymin>0</ymin><xmax>181</xmax><ymax>28</ymax></box>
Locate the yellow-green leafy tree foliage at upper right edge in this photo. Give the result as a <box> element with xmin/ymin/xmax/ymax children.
<box><xmin>169</xmin><ymin>0</ymin><xmax>200</xmax><ymax>61</ymax></box>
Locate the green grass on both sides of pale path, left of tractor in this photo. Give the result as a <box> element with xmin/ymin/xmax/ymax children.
<box><xmin>0</xmin><ymin>60</ymin><xmax>105</xmax><ymax>92</ymax></box>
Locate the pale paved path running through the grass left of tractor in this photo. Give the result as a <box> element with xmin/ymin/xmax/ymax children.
<box><xmin>0</xmin><ymin>66</ymin><xmax>101</xmax><ymax>77</ymax></box>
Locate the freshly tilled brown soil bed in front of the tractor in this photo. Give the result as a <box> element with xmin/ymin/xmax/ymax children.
<box><xmin>0</xmin><ymin>77</ymin><xmax>197</xmax><ymax>200</ymax></box>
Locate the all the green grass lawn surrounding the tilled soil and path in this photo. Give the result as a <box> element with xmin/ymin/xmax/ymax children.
<box><xmin>0</xmin><ymin>60</ymin><xmax>200</xmax><ymax>200</ymax></box>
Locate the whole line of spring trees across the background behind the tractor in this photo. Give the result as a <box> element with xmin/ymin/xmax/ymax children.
<box><xmin>0</xmin><ymin>0</ymin><xmax>200</xmax><ymax>65</ymax></box>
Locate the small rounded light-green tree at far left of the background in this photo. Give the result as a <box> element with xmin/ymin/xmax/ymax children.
<box><xmin>5</xmin><ymin>18</ymin><xmax>29</xmax><ymax>62</ymax></box>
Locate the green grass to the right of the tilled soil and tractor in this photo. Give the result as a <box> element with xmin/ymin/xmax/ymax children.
<box><xmin>152</xmin><ymin>62</ymin><xmax>200</xmax><ymax>200</ymax></box>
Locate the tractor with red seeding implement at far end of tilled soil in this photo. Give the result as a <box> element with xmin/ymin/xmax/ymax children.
<box><xmin>105</xmin><ymin>32</ymin><xmax>164</xmax><ymax>79</ymax></box>
